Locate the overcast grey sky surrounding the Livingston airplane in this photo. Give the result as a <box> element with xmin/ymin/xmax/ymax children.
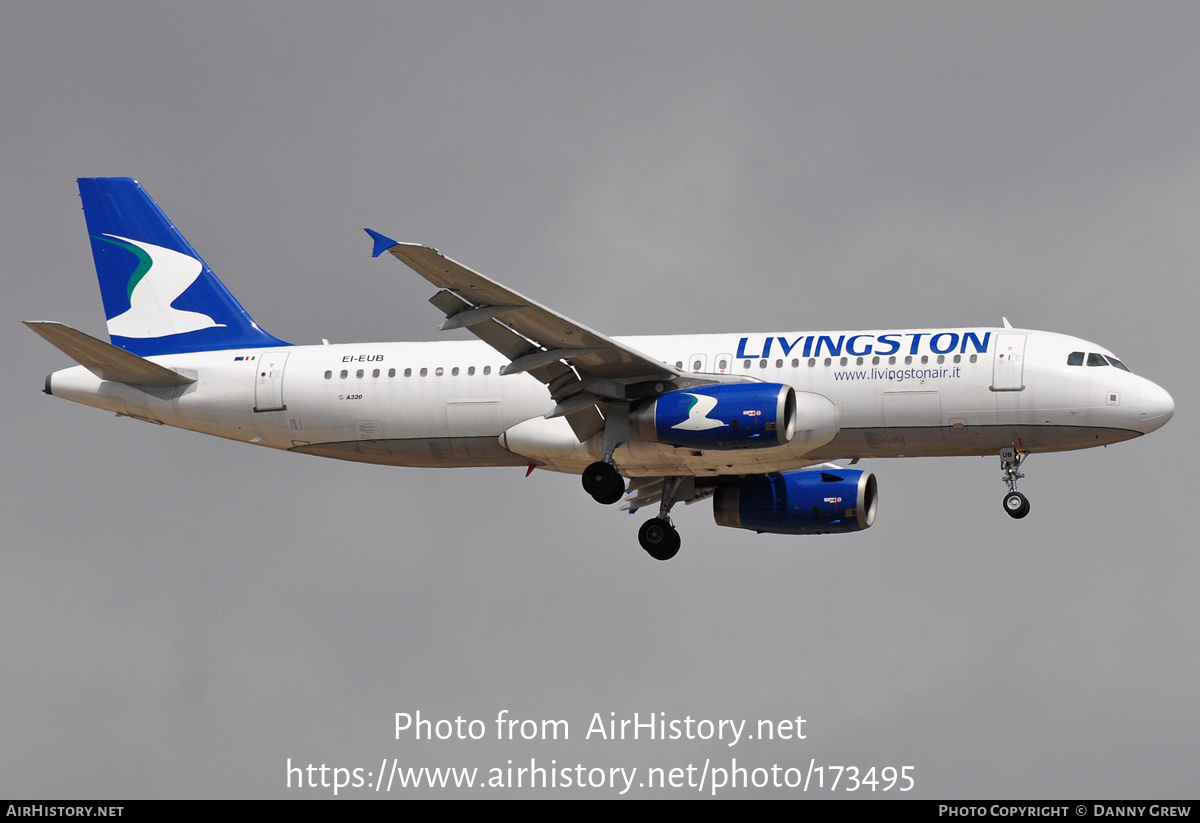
<box><xmin>0</xmin><ymin>2</ymin><xmax>1200</xmax><ymax>798</ymax></box>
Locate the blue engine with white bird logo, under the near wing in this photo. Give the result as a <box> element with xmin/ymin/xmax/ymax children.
<box><xmin>629</xmin><ymin>383</ymin><xmax>796</xmax><ymax>449</ymax></box>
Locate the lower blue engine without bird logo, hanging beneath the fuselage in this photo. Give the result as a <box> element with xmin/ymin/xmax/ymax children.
<box><xmin>713</xmin><ymin>469</ymin><xmax>878</xmax><ymax>534</ymax></box>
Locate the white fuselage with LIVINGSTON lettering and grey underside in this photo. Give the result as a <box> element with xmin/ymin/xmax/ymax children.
<box><xmin>47</xmin><ymin>329</ymin><xmax>1174</xmax><ymax>476</ymax></box>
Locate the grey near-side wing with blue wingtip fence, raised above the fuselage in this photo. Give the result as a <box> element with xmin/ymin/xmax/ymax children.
<box><xmin>366</xmin><ymin>229</ymin><xmax>680</xmax><ymax>441</ymax></box>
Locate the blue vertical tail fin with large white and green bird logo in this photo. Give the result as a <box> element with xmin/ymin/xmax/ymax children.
<box><xmin>79</xmin><ymin>178</ymin><xmax>288</xmax><ymax>356</ymax></box>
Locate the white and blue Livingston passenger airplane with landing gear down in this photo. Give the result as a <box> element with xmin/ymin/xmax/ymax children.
<box><xmin>26</xmin><ymin>178</ymin><xmax>1175</xmax><ymax>560</ymax></box>
